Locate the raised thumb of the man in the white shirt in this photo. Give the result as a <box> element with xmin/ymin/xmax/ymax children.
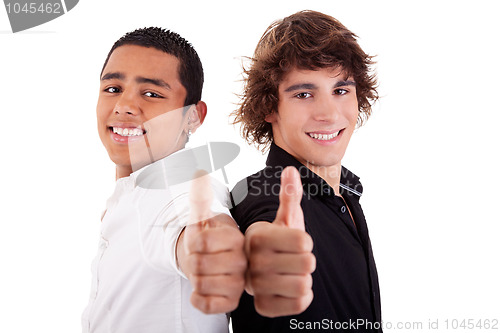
<box><xmin>189</xmin><ymin>170</ymin><xmax>213</xmax><ymax>227</ymax></box>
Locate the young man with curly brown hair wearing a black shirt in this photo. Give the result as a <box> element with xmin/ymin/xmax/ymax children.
<box><xmin>231</xmin><ymin>11</ymin><xmax>381</xmax><ymax>333</ymax></box>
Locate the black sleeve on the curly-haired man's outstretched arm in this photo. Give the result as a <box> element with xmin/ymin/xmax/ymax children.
<box><xmin>231</xmin><ymin>176</ymin><xmax>280</xmax><ymax>233</ymax></box>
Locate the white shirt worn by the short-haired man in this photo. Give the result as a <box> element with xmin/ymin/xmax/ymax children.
<box><xmin>82</xmin><ymin>150</ymin><xmax>229</xmax><ymax>333</ymax></box>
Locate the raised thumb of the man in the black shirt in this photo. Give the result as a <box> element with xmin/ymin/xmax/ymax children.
<box><xmin>273</xmin><ymin>167</ymin><xmax>305</xmax><ymax>231</ymax></box>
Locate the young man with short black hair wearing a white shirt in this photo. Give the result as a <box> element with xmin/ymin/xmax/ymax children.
<box><xmin>82</xmin><ymin>28</ymin><xmax>247</xmax><ymax>333</ymax></box>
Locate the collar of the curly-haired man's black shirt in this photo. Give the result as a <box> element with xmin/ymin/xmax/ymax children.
<box><xmin>266</xmin><ymin>142</ymin><xmax>363</xmax><ymax>198</ymax></box>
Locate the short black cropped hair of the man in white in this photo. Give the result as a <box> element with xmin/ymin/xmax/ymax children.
<box><xmin>101</xmin><ymin>27</ymin><xmax>204</xmax><ymax>106</ymax></box>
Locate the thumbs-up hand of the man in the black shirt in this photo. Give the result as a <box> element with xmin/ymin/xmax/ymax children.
<box><xmin>245</xmin><ymin>167</ymin><xmax>316</xmax><ymax>317</ymax></box>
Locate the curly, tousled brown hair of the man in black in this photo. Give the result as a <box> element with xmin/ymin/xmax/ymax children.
<box><xmin>231</xmin><ymin>10</ymin><xmax>378</xmax><ymax>152</ymax></box>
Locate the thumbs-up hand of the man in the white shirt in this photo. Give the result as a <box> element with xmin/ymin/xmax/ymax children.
<box><xmin>177</xmin><ymin>172</ymin><xmax>247</xmax><ymax>313</ymax></box>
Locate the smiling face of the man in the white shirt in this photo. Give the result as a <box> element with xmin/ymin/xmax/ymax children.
<box><xmin>97</xmin><ymin>45</ymin><xmax>191</xmax><ymax>178</ymax></box>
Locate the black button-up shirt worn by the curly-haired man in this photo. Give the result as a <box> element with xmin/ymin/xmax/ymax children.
<box><xmin>231</xmin><ymin>144</ymin><xmax>382</xmax><ymax>333</ymax></box>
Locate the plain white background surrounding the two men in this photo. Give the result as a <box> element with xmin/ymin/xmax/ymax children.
<box><xmin>0</xmin><ymin>0</ymin><xmax>500</xmax><ymax>332</ymax></box>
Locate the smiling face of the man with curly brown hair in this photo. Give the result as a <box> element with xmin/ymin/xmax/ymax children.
<box><xmin>266</xmin><ymin>68</ymin><xmax>358</xmax><ymax>176</ymax></box>
